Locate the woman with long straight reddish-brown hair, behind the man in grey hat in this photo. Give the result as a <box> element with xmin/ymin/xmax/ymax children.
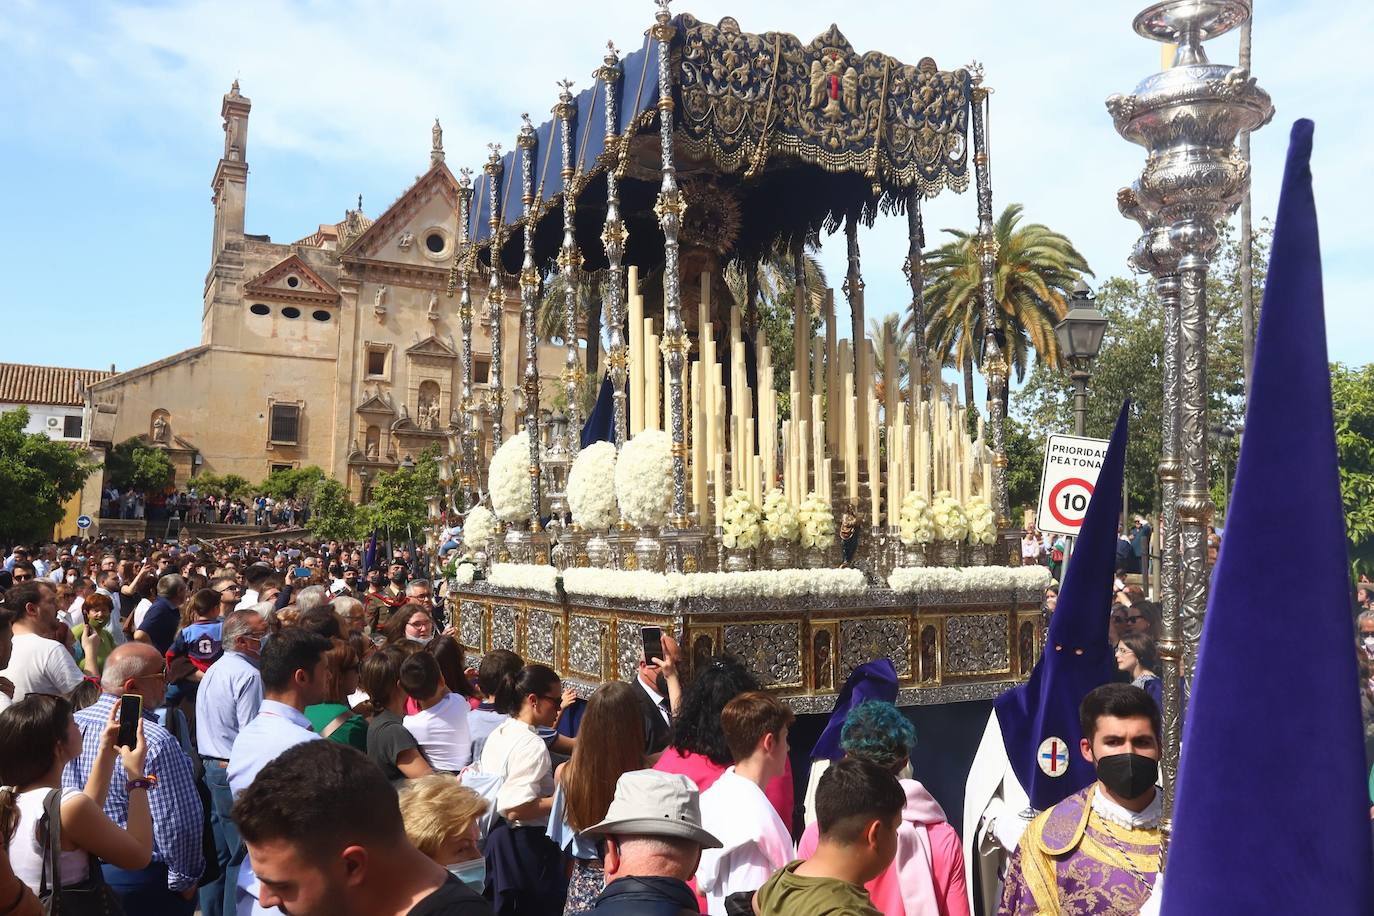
<box><xmin>548</xmin><ymin>681</ymin><xmax>646</xmax><ymax>916</ymax></box>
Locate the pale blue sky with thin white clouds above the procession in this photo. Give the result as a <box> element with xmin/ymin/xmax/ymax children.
<box><xmin>0</xmin><ymin>0</ymin><xmax>1374</xmax><ymax>390</ymax></box>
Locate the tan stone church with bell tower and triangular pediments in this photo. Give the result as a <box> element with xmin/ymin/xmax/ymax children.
<box><xmin>87</xmin><ymin>81</ymin><xmax>563</xmax><ymax>499</ymax></box>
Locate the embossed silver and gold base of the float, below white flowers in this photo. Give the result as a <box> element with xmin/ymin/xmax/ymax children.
<box><xmin>451</xmin><ymin>581</ymin><xmax>1044</xmax><ymax>713</ymax></box>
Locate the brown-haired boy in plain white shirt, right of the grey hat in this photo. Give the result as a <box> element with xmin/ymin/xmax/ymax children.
<box><xmin>697</xmin><ymin>691</ymin><xmax>796</xmax><ymax>916</ymax></box>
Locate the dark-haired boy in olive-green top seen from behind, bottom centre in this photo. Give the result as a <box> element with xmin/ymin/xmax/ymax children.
<box><xmin>754</xmin><ymin>757</ymin><xmax>905</xmax><ymax>916</ymax></box>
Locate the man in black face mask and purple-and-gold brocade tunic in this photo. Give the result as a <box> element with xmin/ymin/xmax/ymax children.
<box><xmin>998</xmin><ymin>684</ymin><xmax>1161</xmax><ymax>916</ymax></box>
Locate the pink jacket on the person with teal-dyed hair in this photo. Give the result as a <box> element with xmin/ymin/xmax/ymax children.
<box><xmin>797</xmin><ymin>779</ymin><xmax>969</xmax><ymax>916</ymax></box>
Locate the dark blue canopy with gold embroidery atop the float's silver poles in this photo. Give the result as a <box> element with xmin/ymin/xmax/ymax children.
<box><xmin>469</xmin><ymin>15</ymin><xmax>974</xmax><ymax>271</ymax></box>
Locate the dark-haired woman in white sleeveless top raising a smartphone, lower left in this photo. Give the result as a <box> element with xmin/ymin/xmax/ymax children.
<box><xmin>0</xmin><ymin>694</ymin><xmax>153</xmax><ymax>893</ymax></box>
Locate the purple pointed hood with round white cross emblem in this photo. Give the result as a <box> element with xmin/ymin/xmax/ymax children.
<box><xmin>993</xmin><ymin>401</ymin><xmax>1131</xmax><ymax>810</ymax></box>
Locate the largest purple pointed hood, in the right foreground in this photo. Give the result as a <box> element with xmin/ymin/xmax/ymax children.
<box><xmin>1162</xmin><ymin>119</ymin><xmax>1374</xmax><ymax>916</ymax></box>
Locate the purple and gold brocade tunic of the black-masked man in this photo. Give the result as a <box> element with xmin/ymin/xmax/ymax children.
<box><xmin>998</xmin><ymin>784</ymin><xmax>1160</xmax><ymax>916</ymax></box>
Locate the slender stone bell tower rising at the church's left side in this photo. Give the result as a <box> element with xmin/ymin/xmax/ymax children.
<box><xmin>201</xmin><ymin>80</ymin><xmax>253</xmax><ymax>343</ymax></box>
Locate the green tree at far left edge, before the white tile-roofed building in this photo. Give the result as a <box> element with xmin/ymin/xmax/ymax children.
<box><xmin>0</xmin><ymin>407</ymin><xmax>100</xmax><ymax>544</ymax></box>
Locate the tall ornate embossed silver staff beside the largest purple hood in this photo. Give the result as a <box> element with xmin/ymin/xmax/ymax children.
<box><xmin>1107</xmin><ymin>0</ymin><xmax>1274</xmax><ymax>851</ymax></box>
